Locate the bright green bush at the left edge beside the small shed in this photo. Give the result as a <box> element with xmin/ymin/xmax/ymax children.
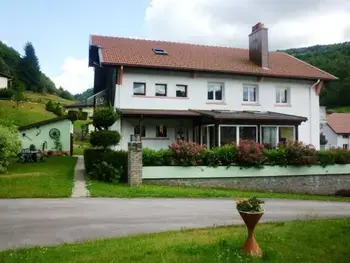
<box><xmin>0</xmin><ymin>125</ymin><xmax>21</xmax><ymax>172</ymax></box>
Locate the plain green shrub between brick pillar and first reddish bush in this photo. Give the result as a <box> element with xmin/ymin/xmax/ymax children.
<box><xmin>142</xmin><ymin>148</ymin><xmax>172</xmax><ymax>166</ymax></box>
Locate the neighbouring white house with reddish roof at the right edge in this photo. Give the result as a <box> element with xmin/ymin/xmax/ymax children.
<box><xmin>321</xmin><ymin>113</ymin><xmax>350</xmax><ymax>149</ymax></box>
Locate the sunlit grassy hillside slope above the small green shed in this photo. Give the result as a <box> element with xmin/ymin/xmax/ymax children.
<box><xmin>0</xmin><ymin>100</ymin><xmax>56</xmax><ymax>126</ymax></box>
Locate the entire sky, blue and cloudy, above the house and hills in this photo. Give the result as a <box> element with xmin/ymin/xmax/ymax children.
<box><xmin>0</xmin><ymin>0</ymin><xmax>350</xmax><ymax>94</ymax></box>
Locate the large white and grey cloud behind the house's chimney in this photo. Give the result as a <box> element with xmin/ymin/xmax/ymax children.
<box><xmin>144</xmin><ymin>0</ymin><xmax>350</xmax><ymax>50</ymax></box>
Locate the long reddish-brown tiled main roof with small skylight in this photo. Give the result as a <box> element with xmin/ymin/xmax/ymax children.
<box><xmin>91</xmin><ymin>35</ymin><xmax>336</xmax><ymax>80</ymax></box>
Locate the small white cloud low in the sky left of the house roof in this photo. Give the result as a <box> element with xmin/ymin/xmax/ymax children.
<box><xmin>51</xmin><ymin>57</ymin><xmax>94</xmax><ymax>94</ymax></box>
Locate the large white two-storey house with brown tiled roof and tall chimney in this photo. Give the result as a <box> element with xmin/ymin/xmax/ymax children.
<box><xmin>89</xmin><ymin>23</ymin><xmax>336</xmax><ymax>149</ymax></box>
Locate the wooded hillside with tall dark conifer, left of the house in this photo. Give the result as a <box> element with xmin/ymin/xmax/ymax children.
<box><xmin>0</xmin><ymin>41</ymin><xmax>74</xmax><ymax>100</ymax></box>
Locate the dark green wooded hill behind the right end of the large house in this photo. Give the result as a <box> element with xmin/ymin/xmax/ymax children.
<box><xmin>284</xmin><ymin>42</ymin><xmax>350</xmax><ymax>108</ymax></box>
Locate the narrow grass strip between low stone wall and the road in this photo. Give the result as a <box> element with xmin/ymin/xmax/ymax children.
<box><xmin>87</xmin><ymin>180</ymin><xmax>350</xmax><ymax>202</ymax></box>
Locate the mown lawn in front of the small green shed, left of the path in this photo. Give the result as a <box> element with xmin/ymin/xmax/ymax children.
<box><xmin>0</xmin><ymin>156</ymin><xmax>76</xmax><ymax>198</ymax></box>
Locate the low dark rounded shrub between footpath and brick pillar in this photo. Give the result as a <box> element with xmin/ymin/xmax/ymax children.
<box><xmin>89</xmin><ymin>161</ymin><xmax>123</xmax><ymax>183</ymax></box>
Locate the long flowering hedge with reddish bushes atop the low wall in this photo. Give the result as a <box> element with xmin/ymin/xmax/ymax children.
<box><xmin>143</xmin><ymin>140</ymin><xmax>350</xmax><ymax>167</ymax></box>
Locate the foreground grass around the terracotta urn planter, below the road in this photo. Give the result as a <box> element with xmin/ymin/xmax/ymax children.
<box><xmin>0</xmin><ymin>219</ymin><xmax>350</xmax><ymax>263</ymax></box>
